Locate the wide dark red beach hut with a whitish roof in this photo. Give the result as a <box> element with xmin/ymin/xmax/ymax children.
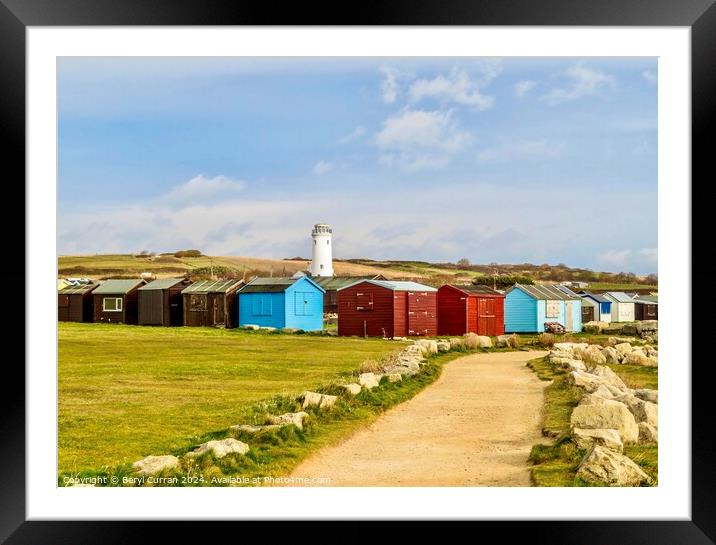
<box><xmin>338</xmin><ymin>280</ymin><xmax>437</xmax><ymax>337</ymax></box>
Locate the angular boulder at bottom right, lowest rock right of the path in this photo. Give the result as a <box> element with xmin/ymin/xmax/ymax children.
<box><xmin>577</xmin><ymin>445</ymin><xmax>650</xmax><ymax>486</ymax></box>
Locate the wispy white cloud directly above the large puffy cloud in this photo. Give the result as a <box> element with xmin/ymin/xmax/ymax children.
<box><xmin>409</xmin><ymin>65</ymin><xmax>500</xmax><ymax>111</ymax></box>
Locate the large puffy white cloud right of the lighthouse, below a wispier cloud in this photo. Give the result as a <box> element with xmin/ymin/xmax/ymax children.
<box><xmin>375</xmin><ymin>109</ymin><xmax>471</xmax><ymax>170</ymax></box>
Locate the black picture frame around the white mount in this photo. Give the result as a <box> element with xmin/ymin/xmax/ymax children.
<box><xmin>0</xmin><ymin>0</ymin><xmax>716</xmax><ymax>545</ymax></box>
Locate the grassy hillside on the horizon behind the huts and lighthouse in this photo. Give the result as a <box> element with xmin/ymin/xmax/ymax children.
<box><xmin>58</xmin><ymin>254</ymin><xmax>657</xmax><ymax>291</ymax></box>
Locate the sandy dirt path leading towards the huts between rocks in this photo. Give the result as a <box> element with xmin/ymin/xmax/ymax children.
<box><xmin>292</xmin><ymin>352</ymin><xmax>549</xmax><ymax>486</ymax></box>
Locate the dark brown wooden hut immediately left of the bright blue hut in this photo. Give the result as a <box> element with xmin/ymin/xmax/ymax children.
<box><xmin>181</xmin><ymin>280</ymin><xmax>244</xmax><ymax>328</ymax></box>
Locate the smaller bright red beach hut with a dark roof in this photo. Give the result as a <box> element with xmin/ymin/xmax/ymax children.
<box><xmin>437</xmin><ymin>284</ymin><xmax>505</xmax><ymax>337</ymax></box>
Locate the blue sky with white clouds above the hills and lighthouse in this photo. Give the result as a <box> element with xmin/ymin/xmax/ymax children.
<box><xmin>58</xmin><ymin>57</ymin><xmax>657</xmax><ymax>274</ymax></box>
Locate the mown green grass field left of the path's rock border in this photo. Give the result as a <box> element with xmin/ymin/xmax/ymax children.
<box><xmin>58</xmin><ymin>323</ymin><xmax>400</xmax><ymax>472</ymax></box>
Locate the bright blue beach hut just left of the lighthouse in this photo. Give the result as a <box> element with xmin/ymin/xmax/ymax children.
<box><xmin>237</xmin><ymin>276</ymin><xmax>325</xmax><ymax>331</ymax></box>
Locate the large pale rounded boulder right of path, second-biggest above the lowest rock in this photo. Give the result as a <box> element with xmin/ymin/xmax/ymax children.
<box><xmin>570</xmin><ymin>395</ymin><xmax>639</xmax><ymax>443</ymax></box>
